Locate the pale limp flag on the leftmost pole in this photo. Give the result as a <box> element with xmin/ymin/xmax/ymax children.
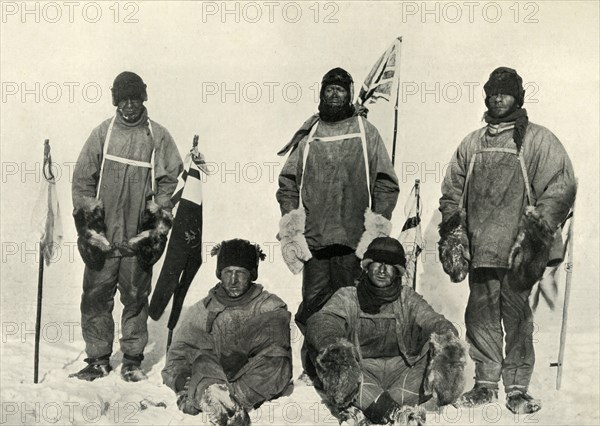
<box><xmin>31</xmin><ymin>139</ymin><xmax>63</xmax><ymax>265</ymax></box>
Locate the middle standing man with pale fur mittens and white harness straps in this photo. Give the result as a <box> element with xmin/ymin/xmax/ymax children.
<box><xmin>277</xmin><ymin>68</ymin><xmax>399</xmax><ymax>378</ymax></box>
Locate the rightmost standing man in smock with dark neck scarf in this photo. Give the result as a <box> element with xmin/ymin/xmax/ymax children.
<box><xmin>439</xmin><ymin>67</ymin><xmax>576</xmax><ymax>413</ymax></box>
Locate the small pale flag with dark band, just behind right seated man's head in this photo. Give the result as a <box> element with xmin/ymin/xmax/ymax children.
<box><xmin>398</xmin><ymin>179</ymin><xmax>425</xmax><ymax>289</ymax></box>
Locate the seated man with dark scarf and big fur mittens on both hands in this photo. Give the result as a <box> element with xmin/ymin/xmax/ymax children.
<box><xmin>307</xmin><ymin>237</ymin><xmax>467</xmax><ymax>425</ymax></box>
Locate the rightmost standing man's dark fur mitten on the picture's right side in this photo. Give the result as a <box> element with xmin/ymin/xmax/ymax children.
<box><xmin>508</xmin><ymin>207</ymin><xmax>554</xmax><ymax>291</ymax></box>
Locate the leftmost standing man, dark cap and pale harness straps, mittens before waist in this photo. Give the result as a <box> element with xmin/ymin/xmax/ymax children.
<box><xmin>71</xmin><ymin>71</ymin><xmax>183</xmax><ymax>382</ymax></box>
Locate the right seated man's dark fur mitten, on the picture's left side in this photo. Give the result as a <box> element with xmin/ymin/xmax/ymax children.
<box><xmin>316</xmin><ymin>339</ymin><xmax>362</xmax><ymax>409</ymax></box>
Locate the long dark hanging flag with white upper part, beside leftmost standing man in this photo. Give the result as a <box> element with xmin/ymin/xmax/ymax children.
<box><xmin>149</xmin><ymin>135</ymin><xmax>206</xmax><ymax>332</ymax></box>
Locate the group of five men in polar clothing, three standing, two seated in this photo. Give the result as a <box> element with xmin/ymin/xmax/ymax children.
<box><xmin>71</xmin><ymin>67</ymin><xmax>576</xmax><ymax>425</ymax></box>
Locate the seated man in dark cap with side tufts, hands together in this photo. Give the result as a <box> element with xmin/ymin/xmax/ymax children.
<box><xmin>162</xmin><ymin>239</ymin><xmax>292</xmax><ymax>425</ymax></box>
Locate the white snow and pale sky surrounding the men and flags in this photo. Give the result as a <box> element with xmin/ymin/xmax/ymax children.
<box><xmin>0</xmin><ymin>1</ymin><xmax>600</xmax><ymax>425</ymax></box>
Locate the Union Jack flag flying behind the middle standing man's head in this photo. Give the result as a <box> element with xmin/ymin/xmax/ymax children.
<box><xmin>358</xmin><ymin>37</ymin><xmax>402</xmax><ymax>105</ymax></box>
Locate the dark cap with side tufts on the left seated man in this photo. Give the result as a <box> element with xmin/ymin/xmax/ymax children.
<box><xmin>210</xmin><ymin>238</ymin><xmax>266</xmax><ymax>281</ymax></box>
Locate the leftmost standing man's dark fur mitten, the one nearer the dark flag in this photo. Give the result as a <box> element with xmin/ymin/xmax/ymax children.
<box><xmin>127</xmin><ymin>201</ymin><xmax>173</xmax><ymax>269</ymax></box>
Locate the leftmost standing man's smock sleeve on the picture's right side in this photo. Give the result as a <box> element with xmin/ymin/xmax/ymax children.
<box><xmin>154</xmin><ymin>127</ymin><xmax>183</xmax><ymax>211</ymax></box>
